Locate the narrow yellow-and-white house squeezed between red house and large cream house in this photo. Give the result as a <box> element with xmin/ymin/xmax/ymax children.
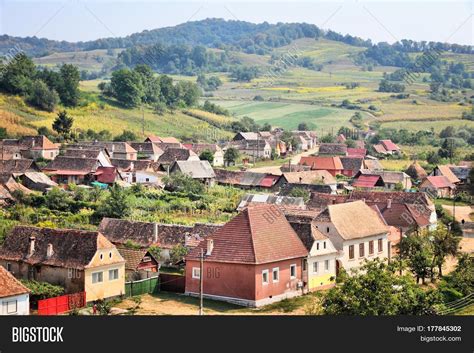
<box><xmin>288</xmin><ymin>216</ymin><xmax>339</xmax><ymax>291</ymax></box>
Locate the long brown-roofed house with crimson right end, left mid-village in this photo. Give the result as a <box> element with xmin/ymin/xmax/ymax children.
<box><xmin>43</xmin><ymin>156</ymin><xmax>116</xmax><ymax>184</ymax></box>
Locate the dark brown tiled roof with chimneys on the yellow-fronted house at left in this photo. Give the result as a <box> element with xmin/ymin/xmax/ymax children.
<box><xmin>0</xmin><ymin>226</ymin><xmax>119</xmax><ymax>269</ymax></box>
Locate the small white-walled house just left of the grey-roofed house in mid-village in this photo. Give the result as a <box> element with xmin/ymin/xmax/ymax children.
<box><xmin>111</xmin><ymin>159</ymin><xmax>166</xmax><ymax>186</ymax></box>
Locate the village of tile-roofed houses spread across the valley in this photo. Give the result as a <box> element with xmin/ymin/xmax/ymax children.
<box><xmin>0</xmin><ymin>129</ymin><xmax>474</xmax><ymax>315</ymax></box>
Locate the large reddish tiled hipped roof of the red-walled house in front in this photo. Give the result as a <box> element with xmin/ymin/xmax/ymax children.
<box><xmin>186</xmin><ymin>205</ymin><xmax>308</xmax><ymax>264</ymax></box>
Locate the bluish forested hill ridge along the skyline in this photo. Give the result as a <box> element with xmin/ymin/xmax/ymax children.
<box><xmin>0</xmin><ymin>19</ymin><xmax>473</xmax><ymax>56</ymax></box>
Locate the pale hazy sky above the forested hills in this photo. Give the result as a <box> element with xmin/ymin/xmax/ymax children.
<box><xmin>0</xmin><ymin>0</ymin><xmax>474</xmax><ymax>45</ymax></box>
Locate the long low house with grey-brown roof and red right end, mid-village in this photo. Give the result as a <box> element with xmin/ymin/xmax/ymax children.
<box><xmin>214</xmin><ymin>169</ymin><xmax>283</xmax><ymax>190</ymax></box>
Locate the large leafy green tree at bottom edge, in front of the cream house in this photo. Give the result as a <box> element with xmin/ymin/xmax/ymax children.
<box><xmin>322</xmin><ymin>259</ymin><xmax>441</xmax><ymax>316</ymax></box>
